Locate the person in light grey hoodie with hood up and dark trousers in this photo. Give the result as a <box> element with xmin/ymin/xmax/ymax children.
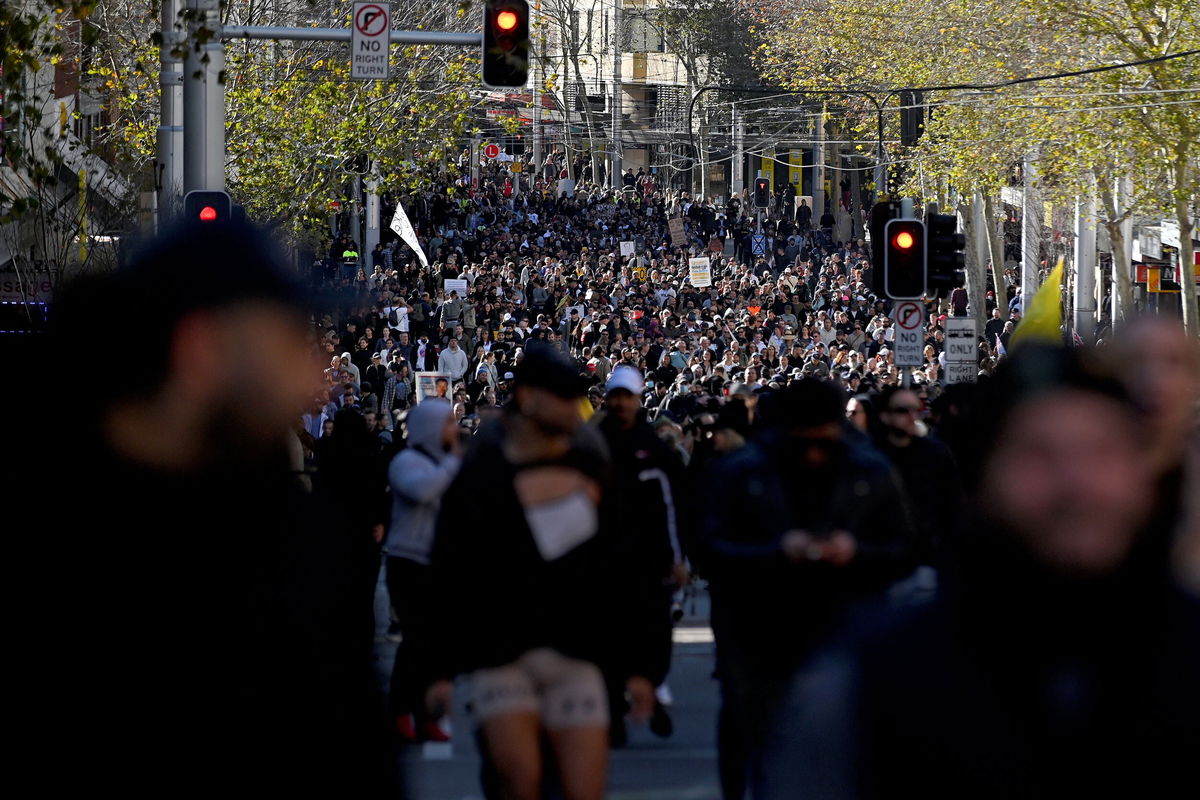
<box><xmin>384</xmin><ymin>397</ymin><xmax>462</xmax><ymax>741</ymax></box>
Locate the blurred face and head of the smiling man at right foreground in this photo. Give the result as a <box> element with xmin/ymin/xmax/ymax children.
<box><xmin>979</xmin><ymin>345</ymin><xmax>1153</xmax><ymax>577</ymax></box>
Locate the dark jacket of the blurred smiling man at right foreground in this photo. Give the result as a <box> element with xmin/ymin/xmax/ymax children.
<box><xmin>755</xmin><ymin>524</ymin><xmax>1200</xmax><ymax>800</ymax></box>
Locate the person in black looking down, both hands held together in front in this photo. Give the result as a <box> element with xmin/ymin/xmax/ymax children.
<box><xmin>702</xmin><ymin>379</ymin><xmax>912</xmax><ymax>800</ymax></box>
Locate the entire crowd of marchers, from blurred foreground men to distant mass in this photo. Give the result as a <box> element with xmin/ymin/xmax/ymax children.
<box><xmin>18</xmin><ymin>151</ymin><xmax>1200</xmax><ymax>800</ymax></box>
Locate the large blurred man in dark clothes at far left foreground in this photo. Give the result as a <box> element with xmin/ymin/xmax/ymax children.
<box><xmin>14</xmin><ymin>219</ymin><xmax>396</xmax><ymax>796</ymax></box>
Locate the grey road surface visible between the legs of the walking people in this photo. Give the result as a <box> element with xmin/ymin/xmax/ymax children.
<box><xmin>376</xmin><ymin>582</ymin><xmax>720</xmax><ymax>800</ymax></box>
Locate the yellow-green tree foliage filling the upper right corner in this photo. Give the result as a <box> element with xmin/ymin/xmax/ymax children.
<box><xmin>755</xmin><ymin>0</ymin><xmax>1200</xmax><ymax>330</ymax></box>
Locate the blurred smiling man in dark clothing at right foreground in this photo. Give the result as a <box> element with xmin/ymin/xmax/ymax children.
<box><xmin>756</xmin><ymin>344</ymin><xmax>1200</xmax><ymax>800</ymax></box>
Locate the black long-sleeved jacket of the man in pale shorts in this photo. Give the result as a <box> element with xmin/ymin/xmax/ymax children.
<box><xmin>428</xmin><ymin>420</ymin><xmax>653</xmax><ymax>678</ymax></box>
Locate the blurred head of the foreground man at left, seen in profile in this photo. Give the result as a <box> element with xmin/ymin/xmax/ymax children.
<box><xmin>52</xmin><ymin>223</ymin><xmax>317</xmax><ymax>470</ymax></box>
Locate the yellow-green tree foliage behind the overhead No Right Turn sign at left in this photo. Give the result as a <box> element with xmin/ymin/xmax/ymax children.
<box><xmin>66</xmin><ymin>0</ymin><xmax>492</xmax><ymax>250</ymax></box>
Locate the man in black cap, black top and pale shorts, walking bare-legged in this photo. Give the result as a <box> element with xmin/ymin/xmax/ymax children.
<box><xmin>428</xmin><ymin>348</ymin><xmax>654</xmax><ymax>800</ymax></box>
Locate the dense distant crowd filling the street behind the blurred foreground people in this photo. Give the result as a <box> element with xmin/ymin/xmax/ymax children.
<box><xmin>304</xmin><ymin>155</ymin><xmax>1021</xmax><ymax>443</ymax></box>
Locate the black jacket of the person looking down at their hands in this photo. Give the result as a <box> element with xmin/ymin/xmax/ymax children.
<box><xmin>701</xmin><ymin>434</ymin><xmax>912</xmax><ymax>674</ymax></box>
